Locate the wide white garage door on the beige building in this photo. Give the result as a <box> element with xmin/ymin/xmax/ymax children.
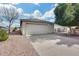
<box><xmin>24</xmin><ymin>24</ymin><xmax>53</xmax><ymax>34</ymax></box>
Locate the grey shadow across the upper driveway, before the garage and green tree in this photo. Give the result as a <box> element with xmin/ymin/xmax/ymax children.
<box><xmin>30</xmin><ymin>34</ymin><xmax>79</xmax><ymax>47</ymax></box>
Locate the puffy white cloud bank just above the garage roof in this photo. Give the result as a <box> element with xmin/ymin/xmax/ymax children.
<box><xmin>21</xmin><ymin>7</ymin><xmax>55</xmax><ymax>22</ymax></box>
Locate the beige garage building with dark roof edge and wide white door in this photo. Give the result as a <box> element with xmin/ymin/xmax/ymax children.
<box><xmin>20</xmin><ymin>19</ymin><xmax>54</xmax><ymax>35</ymax></box>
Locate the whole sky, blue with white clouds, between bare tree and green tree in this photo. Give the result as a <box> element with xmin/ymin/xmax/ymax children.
<box><xmin>0</xmin><ymin>3</ymin><xmax>57</xmax><ymax>26</ymax></box>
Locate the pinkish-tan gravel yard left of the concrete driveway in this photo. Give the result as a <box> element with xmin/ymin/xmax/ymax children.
<box><xmin>0</xmin><ymin>35</ymin><xmax>38</xmax><ymax>56</ymax></box>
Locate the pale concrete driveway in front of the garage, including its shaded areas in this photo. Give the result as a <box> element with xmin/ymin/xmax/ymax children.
<box><xmin>30</xmin><ymin>34</ymin><xmax>79</xmax><ymax>56</ymax></box>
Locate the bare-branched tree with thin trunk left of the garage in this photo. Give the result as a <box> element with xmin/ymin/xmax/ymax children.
<box><xmin>0</xmin><ymin>4</ymin><xmax>22</xmax><ymax>33</ymax></box>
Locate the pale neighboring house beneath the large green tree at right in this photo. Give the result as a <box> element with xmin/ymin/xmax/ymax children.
<box><xmin>54</xmin><ymin>24</ymin><xmax>79</xmax><ymax>34</ymax></box>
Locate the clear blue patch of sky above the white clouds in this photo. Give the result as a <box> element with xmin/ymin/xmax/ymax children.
<box><xmin>16</xmin><ymin>3</ymin><xmax>54</xmax><ymax>14</ymax></box>
